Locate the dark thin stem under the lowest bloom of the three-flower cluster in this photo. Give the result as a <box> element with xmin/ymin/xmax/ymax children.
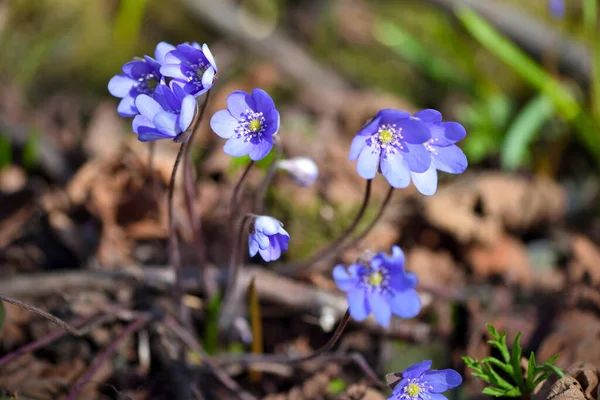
<box><xmin>168</xmin><ymin>141</ymin><xmax>187</xmax><ymax>320</ymax></box>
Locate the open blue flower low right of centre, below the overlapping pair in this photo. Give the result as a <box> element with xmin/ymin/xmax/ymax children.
<box><xmin>333</xmin><ymin>246</ymin><xmax>421</xmax><ymax>326</ymax></box>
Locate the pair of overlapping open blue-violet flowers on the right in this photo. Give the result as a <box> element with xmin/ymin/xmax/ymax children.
<box><xmin>349</xmin><ymin>109</ymin><xmax>467</xmax><ymax>195</ymax></box>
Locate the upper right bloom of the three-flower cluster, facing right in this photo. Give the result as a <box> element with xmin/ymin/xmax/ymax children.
<box><xmin>160</xmin><ymin>42</ymin><xmax>217</xmax><ymax>96</ymax></box>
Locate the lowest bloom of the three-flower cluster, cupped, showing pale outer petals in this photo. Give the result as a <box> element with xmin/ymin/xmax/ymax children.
<box><xmin>133</xmin><ymin>84</ymin><xmax>196</xmax><ymax>142</ymax></box>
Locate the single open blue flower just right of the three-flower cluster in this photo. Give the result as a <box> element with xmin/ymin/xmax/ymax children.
<box><xmin>210</xmin><ymin>89</ymin><xmax>279</xmax><ymax>161</ymax></box>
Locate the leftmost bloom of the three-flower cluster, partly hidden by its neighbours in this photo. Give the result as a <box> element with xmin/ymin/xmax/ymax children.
<box><xmin>108</xmin><ymin>42</ymin><xmax>175</xmax><ymax>117</ymax></box>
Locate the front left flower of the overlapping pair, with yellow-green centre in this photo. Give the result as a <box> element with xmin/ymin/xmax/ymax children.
<box><xmin>349</xmin><ymin>109</ymin><xmax>431</xmax><ymax>188</ymax></box>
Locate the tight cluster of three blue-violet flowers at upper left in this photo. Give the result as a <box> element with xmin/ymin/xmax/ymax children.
<box><xmin>108</xmin><ymin>42</ymin><xmax>217</xmax><ymax>142</ymax></box>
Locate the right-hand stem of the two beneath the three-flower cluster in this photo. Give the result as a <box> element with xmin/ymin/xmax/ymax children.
<box><xmin>183</xmin><ymin>90</ymin><xmax>216</xmax><ymax>298</ymax></box>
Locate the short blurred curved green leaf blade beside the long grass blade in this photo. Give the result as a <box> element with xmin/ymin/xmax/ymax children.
<box><xmin>500</xmin><ymin>94</ymin><xmax>554</xmax><ymax>170</ymax></box>
